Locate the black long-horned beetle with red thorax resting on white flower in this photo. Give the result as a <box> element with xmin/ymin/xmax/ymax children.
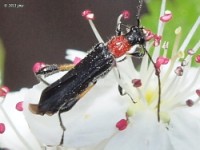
<box><xmin>30</xmin><ymin>0</ymin><xmax>152</xmax><ymax>145</ymax></box>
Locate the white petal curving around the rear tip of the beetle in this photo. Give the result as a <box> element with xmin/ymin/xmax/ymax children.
<box><xmin>24</xmin><ymin>72</ymin><xmax>69</xmax><ymax>145</ymax></box>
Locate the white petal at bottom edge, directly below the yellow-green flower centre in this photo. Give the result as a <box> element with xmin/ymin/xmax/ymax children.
<box><xmin>105</xmin><ymin>111</ymin><xmax>172</xmax><ymax>150</ymax></box>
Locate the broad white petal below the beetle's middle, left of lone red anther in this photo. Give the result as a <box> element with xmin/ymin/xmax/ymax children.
<box><xmin>62</xmin><ymin>77</ymin><xmax>127</xmax><ymax>147</ymax></box>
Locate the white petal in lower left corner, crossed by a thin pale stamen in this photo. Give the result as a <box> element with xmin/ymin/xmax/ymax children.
<box><xmin>0</xmin><ymin>89</ymin><xmax>40</xmax><ymax>150</ymax></box>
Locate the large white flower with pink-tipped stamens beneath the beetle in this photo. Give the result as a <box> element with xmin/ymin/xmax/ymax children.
<box><xmin>0</xmin><ymin>1</ymin><xmax>200</xmax><ymax>150</ymax></box>
